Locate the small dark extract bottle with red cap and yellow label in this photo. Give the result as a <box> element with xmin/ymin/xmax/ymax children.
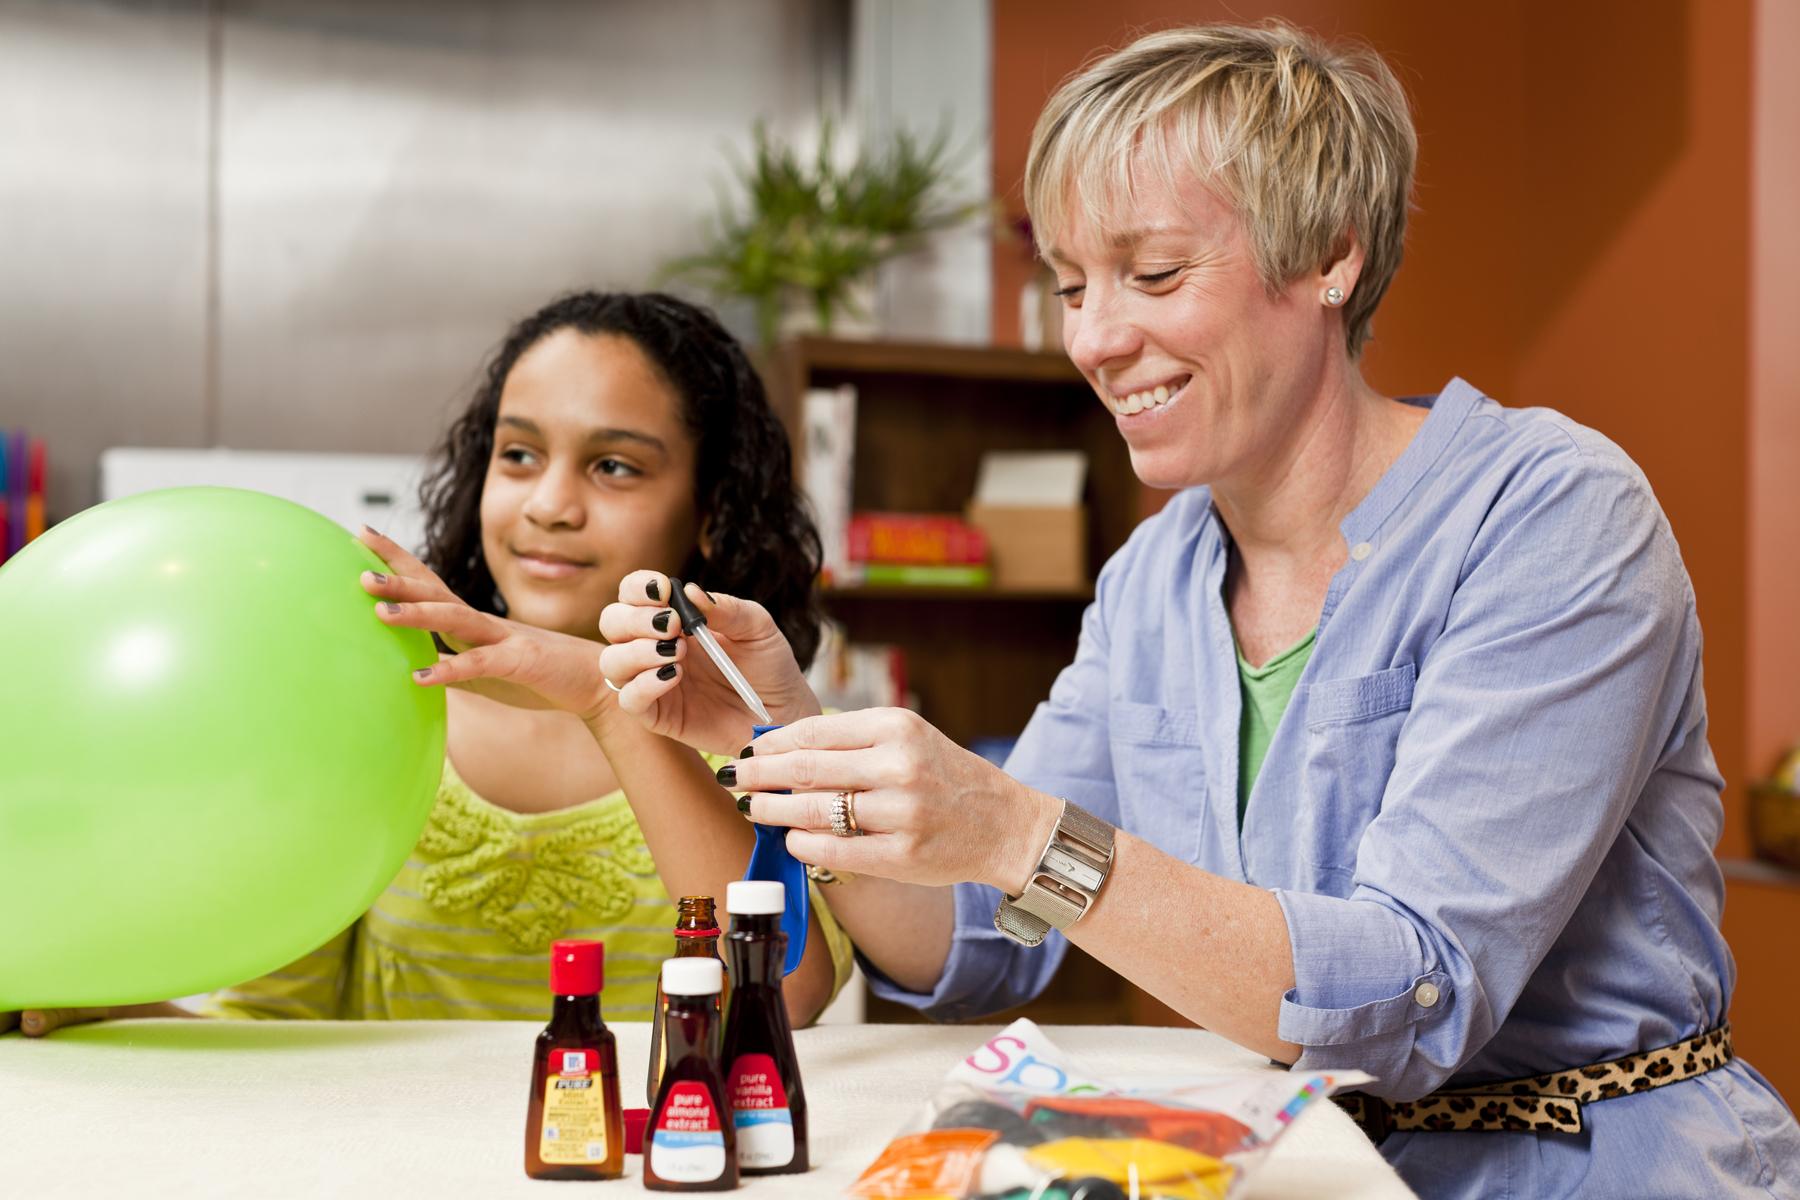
<box><xmin>526</xmin><ymin>939</ymin><xmax>625</xmax><ymax>1178</ymax></box>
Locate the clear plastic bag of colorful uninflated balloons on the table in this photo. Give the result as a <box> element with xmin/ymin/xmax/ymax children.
<box><xmin>848</xmin><ymin>1020</ymin><xmax>1370</xmax><ymax>1200</ymax></box>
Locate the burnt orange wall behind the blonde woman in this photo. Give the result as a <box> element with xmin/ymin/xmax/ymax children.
<box><xmin>994</xmin><ymin>0</ymin><xmax>1800</xmax><ymax>1094</ymax></box>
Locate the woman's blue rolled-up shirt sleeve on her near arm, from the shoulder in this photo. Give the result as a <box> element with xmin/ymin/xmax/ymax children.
<box><xmin>1276</xmin><ymin>453</ymin><xmax>1705</xmax><ymax>1099</ymax></box>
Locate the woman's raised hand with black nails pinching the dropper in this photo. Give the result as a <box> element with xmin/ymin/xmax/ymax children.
<box><xmin>599</xmin><ymin>570</ymin><xmax>819</xmax><ymax>754</ymax></box>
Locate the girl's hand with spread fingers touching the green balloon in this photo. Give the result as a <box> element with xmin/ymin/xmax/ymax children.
<box><xmin>358</xmin><ymin>529</ymin><xmax>612</xmax><ymax>721</ymax></box>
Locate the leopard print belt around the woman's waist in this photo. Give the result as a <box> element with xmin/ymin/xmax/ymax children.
<box><xmin>1332</xmin><ymin>1024</ymin><xmax>1732</xmax><ymax>1144</ymax></box>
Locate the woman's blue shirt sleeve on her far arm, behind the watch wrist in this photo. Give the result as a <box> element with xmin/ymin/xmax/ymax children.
<box><xmin>862</xmin><ymin>547</ymin><xmax>1130</xmax><ymax>1020</ymax></box>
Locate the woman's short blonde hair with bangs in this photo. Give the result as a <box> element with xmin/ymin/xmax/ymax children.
<box><xmin>1024</xmin><ymin>22</ymin><xmax>1418</xmax><ymax>358</ymax></box>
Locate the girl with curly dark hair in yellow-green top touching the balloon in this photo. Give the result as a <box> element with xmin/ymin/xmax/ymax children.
<box><xmin>175</xmin><ymin>291</ymin><xmax>850</xmax><ymax>1020</ymax></box>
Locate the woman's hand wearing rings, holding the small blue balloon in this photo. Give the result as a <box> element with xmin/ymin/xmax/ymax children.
<box><xmin>720</xmin><ymin>709</ymin><xmax>1062</xmax><ymax>896</ymax></box>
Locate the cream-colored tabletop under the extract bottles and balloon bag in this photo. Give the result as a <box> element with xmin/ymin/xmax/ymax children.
<box><xmin>0</xmin><ymin>1020</ymin><xmax>1413</xmax><ymax>1200</ymax></box>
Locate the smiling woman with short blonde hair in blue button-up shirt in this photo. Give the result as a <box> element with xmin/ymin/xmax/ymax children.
<box><xmin>390</xmin><ymin>25</ymin><xmax>1800</xmax><ymax>1198</ymax></box>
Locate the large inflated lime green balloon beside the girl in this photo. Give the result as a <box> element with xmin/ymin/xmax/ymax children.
<box><xmin>0</xmin><ymin>488</ymin><xmax>445</xmax><ymax>1011</ymax></box>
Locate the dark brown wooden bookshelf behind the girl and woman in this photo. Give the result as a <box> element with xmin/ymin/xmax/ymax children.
<box><xmin>765</xmin><ymin>336</ymin><xmax>1179</xmax><ymax>1024</ymax></box>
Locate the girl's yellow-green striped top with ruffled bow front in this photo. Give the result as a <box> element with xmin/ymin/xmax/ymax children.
<box><xmin>200</xmin><ymin>757</ymin><xmax>851</xmax><ymax>1020</ymax></box>
